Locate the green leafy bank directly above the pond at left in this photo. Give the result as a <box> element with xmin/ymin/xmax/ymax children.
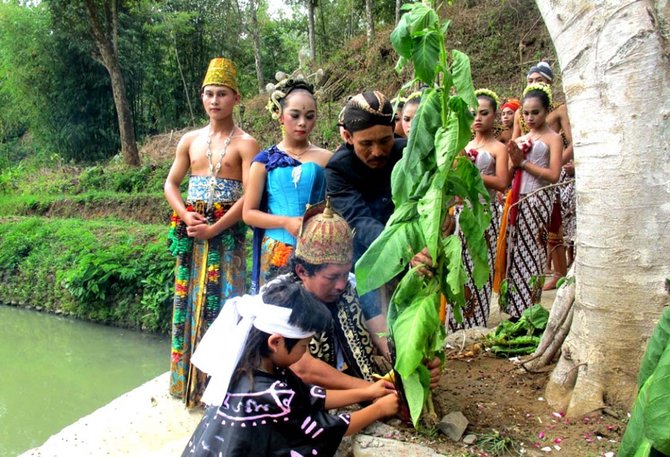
<box><xmin>0</xmin><ymin>217</ymin><xmax>174</xmax><ymax>331</ymax></box>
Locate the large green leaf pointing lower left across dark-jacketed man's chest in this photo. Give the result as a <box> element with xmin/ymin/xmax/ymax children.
<box><xmin>355</xmin><ymin>222</ymin><xmax>424</xmax><ymax>295</ymax></box>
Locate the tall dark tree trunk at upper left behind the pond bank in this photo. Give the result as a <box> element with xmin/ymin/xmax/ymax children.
<box><xmin>84</xmin><ymin>0</ymin><xmax>140</xmax><ymax>166</ymax></box>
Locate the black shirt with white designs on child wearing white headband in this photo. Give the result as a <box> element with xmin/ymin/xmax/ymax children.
<box><xmin>182</xmin><ymin>368</ymin><xmax>351</xmax><ymax>457</ymax></box>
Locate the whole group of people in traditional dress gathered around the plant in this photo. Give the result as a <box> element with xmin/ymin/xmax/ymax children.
<box><xmin>165</xmin><ymin>58</ymin><xmax>574</xmax><ymax>456</ymax></box>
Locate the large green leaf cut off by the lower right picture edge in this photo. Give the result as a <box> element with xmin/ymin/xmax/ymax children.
<box><xmin>643</xmin><ymin>345</ymin><xmax>670</xmax><ymax>455</ymax></box>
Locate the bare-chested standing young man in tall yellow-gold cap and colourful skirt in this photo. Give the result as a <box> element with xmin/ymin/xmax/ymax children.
<box><xmin>164</xmin><ymin>58</ymin><xmax>259</xmax><ymax>407</ymax></box>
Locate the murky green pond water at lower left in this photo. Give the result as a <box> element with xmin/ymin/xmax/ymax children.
<box><xmin>0</xmin><ymin>305</ymin><xmax>170</xmax><ymax>457</ymax></box>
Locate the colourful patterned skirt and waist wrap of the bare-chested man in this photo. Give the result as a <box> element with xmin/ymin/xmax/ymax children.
<box><xmin>168</xmin><ymin>176</ymin><xmax>246</xmax><ymax>408</ymax></box>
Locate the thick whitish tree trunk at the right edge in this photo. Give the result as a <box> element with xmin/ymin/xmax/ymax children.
<box><xmin>537</xmin><ymin>0</ymin><xmax>670</xmax><ymax>417</ymax></box>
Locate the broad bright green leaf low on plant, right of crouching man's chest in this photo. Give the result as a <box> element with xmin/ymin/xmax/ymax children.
<box><xmin>393</xmin><ymin>293</ymin><xmax>440</xmax><ymax>378</ymax></box>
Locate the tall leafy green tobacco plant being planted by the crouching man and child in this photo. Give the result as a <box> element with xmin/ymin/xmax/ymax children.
<box><xmin>356</xmin><ymin>3</ymin><xmax>491</xmax><ymax>427</ymax></box>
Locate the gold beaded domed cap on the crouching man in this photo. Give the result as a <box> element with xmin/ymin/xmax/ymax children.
<box><xmin>295</xmin><ymin>197</ymin><xmax>354</xmax><ymax>265</ymax></box>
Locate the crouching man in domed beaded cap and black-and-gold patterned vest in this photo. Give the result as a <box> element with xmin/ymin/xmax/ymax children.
<box><xmin>280</xmin><ymin>199</ymin><xmax>440</xmax><ymax>389</ymax></box>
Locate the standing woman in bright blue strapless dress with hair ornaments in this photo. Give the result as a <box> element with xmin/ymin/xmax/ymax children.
<box><xmin>242</xmin><ymin>77</ymin><xmax>332</xmax><ymax>293</ymax></box>
